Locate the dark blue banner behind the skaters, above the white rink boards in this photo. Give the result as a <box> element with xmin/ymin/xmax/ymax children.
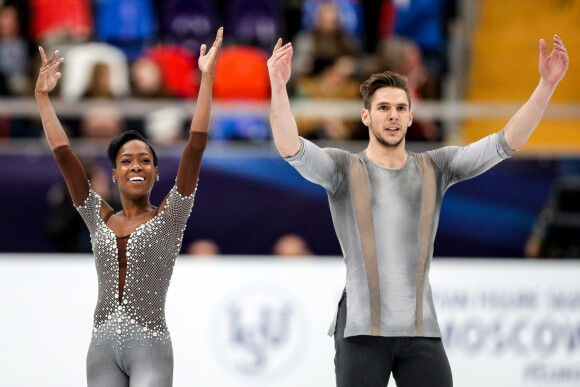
<box><xmin>0</xmin><ymin>147</ymin><xmax>560</xmax><ymax>257</ymax></box>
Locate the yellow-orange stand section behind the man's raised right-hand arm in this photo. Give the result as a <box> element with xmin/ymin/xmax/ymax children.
<box><xmin>463</xmin><ymin>0</ymin><xmax>580</xmax><ymax>152</ymax></box>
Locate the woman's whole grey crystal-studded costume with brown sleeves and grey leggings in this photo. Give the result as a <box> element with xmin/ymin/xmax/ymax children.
<box><xmin>53</xmin><ymin>131</ymin><xmax>207</xmax><ymax>387</ymax></box>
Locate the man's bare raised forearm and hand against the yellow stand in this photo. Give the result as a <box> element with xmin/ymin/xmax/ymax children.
<box><xmin>504</xmin><ymin>35</ymin><xmax>568</xmax><ymax>151</ymax></box>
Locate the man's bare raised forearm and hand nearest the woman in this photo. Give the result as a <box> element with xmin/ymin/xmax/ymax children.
<box><xmin>268</xmin><ymin>39</ymin><xmax>300</xmax><ymax>157</ymax></box>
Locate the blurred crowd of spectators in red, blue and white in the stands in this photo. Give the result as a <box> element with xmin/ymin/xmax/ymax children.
<box><xmin>0</xmin><ymin>0</ymin><xmax>456</xmax><ymax>144</ymax></box>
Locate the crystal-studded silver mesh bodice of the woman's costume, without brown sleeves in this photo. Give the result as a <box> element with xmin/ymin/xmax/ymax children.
<box><xmin>77</xmin><ymin>186</ymin><xmax>195</xmax><ymax>352</ymax></box>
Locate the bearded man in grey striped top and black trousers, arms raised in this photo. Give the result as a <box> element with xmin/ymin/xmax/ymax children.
<box><xmin>268</xmin><ymin>36</ymin><xmax>568</xmax><ymax>387</ymax></box>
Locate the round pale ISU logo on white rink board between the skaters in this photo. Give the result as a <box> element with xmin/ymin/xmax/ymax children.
<box><xmin>210</xmin><ymin>285</ymin><xmax>308</xmax><ymax>380</ymax></box>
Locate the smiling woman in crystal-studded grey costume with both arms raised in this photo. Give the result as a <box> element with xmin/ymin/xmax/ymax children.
<box><xmin>35</xmin><ymin>28</ymin><xmax>223</xmax><ymax>387</ymax></box>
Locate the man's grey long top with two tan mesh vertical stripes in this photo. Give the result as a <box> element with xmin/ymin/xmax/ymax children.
<box><xmin>286</xmin><ymin>131</ymin><xmax>514</xmax><ymax>337</ymax></box>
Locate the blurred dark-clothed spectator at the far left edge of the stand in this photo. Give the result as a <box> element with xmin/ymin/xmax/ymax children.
<box><xmin>0</xmin><ymin>5</ymin><xmax>29</xmax><ymax>95</ymax></box>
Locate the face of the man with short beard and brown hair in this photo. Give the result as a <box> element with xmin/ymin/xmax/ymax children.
<box><xmin>362</xmin><ymin>87</ymin><xmax>413</xmax><ymax>148</ymax></box>
